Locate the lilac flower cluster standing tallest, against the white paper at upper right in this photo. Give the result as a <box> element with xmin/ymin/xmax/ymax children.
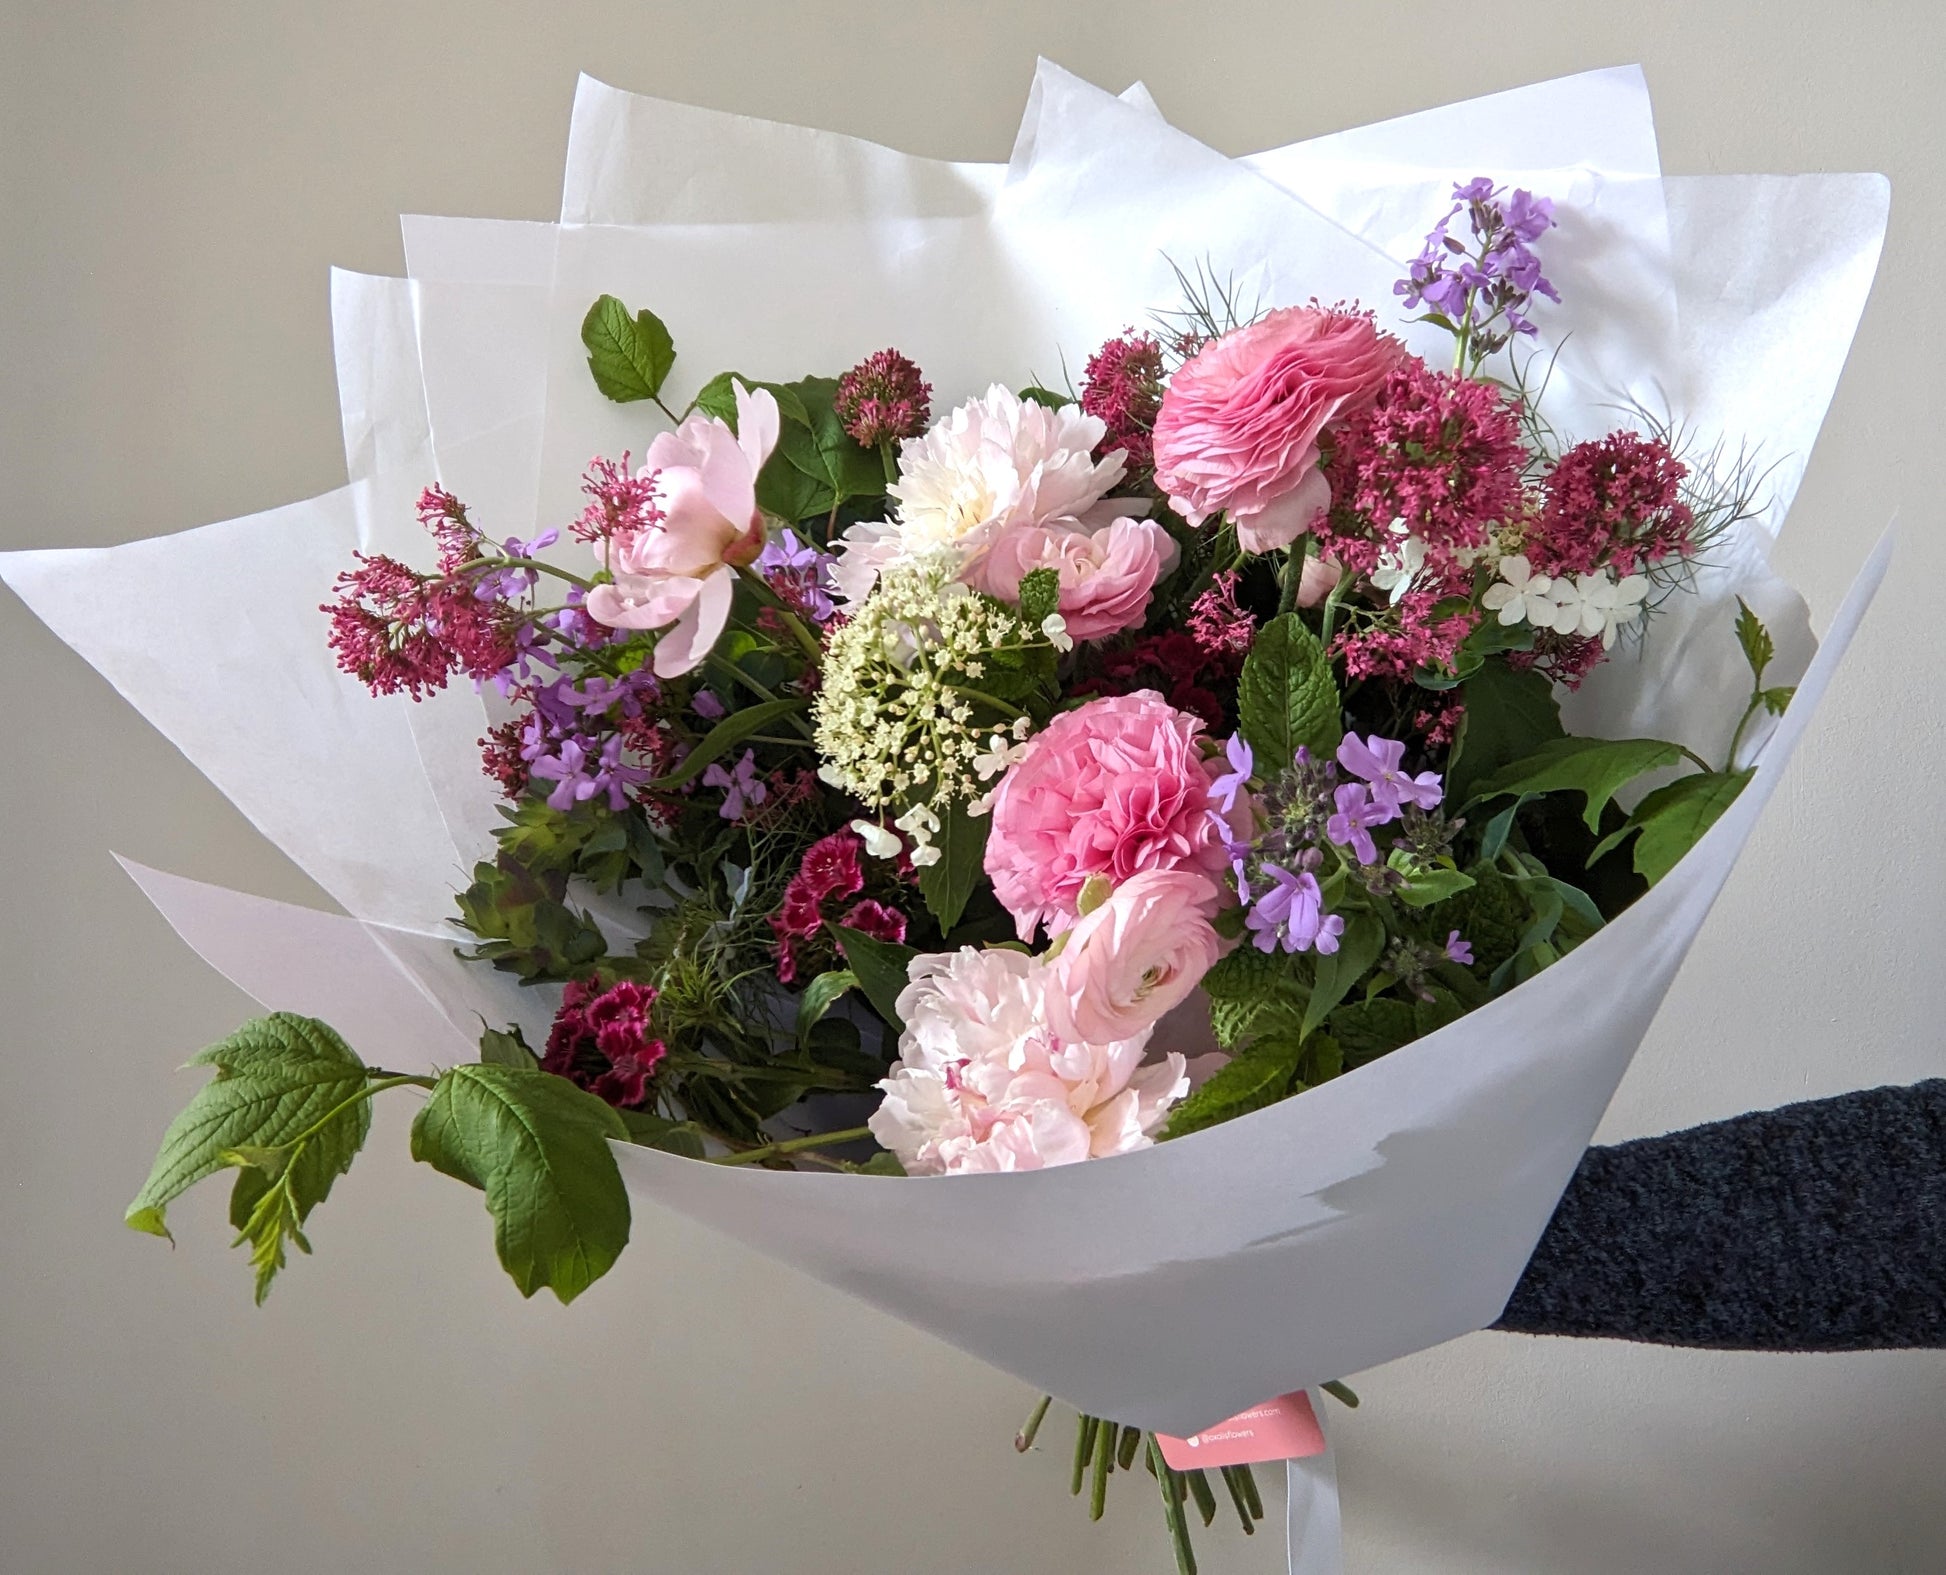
<box><xmin>1391</xmin><ymin>175</ymin><xmax>1561</xmax><ymax>352</ymax></box>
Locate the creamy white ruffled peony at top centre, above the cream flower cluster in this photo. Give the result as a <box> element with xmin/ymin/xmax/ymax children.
<box><xmin>833</xmin><ymin>384</ymin><xmax>1144</xmax><ymax>602</ymax></box>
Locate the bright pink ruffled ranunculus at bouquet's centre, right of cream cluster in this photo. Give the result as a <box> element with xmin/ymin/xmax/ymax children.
<box><xmin>987</xmin><ymin>689</ymin><xmax>1249</xmax><ymax>940</ymax></box>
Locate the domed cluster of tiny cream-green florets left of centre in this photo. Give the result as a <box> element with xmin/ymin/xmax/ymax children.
<box><xmin>811</xmin><ymin>565</ymin><xmax>1049</xmax><ymax>848</ymax></box>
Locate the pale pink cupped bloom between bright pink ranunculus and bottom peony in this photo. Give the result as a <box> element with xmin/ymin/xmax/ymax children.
<box><xmin>1047</xmin><ymin>870</ymin><xmax>1222</xmax><ymax>1042</ymax></box>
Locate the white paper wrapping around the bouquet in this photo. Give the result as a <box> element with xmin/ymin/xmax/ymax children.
<box><xmin>0</xmin><ymin>66</ymin><xmax>1890</xmax><ymax>1435</ymax></box>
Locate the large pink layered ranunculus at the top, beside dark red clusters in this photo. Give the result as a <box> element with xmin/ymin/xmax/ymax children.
<box><xmin>1156</xmin><ymin>306</ymin><xmax>1405</xmax><ymax>553</ymax></box>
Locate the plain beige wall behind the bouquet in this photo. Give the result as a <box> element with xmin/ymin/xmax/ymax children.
<box><xmin>0</xmin><ymin>0</ymin><xmax>1946</xmax><ymax>1575</ymax></box>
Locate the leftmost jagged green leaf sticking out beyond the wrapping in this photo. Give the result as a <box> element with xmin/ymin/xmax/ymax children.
<box><xmin>126</xmin><ymin>1012</ymin><xmax>372</xmax><ymax>1245</ymax></box>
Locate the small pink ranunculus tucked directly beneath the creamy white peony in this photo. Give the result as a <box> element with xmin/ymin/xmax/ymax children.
<box><xmin>965</xmin><ymin>520</ymin><xmax>1177</xmax><ymax>641</ymax></box>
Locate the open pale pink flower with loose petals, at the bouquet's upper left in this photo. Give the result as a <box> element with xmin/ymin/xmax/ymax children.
<box><xmin>588</xmin><ymin>384</ymin><xmax>778</xmax><ymax>678</ymax></box>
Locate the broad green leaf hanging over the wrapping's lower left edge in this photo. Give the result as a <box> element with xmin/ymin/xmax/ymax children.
<box><xmin>413</xmin><ymin>1067</ymin><xmax>629</xmax><ymax>1302</ymax></box>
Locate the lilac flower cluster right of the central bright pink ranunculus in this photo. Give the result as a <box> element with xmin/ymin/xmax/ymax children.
<box><xmin>1210</xmin><ymin>734</ymin><xmax>1465</xmax><ymax>956</ymax></box>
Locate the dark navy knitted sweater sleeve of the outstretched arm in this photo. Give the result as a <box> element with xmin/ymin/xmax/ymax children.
<box><xmin>1495</xmin><ymin>1081</ymin><xmax>1946</xmax><ymax>1351</ymax></box>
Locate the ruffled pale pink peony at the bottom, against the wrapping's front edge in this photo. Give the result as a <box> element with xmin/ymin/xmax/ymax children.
<box><xmin>870</xmin><ymin>946</ymin><xmax>1189</xmax><ymax>1176</ymax></box>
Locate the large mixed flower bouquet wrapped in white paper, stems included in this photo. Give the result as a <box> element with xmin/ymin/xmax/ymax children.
<box><xmin>8</xmin><ymin>68</ymin><xmax>1882</xmax><ymax>1569</ymax></box>
